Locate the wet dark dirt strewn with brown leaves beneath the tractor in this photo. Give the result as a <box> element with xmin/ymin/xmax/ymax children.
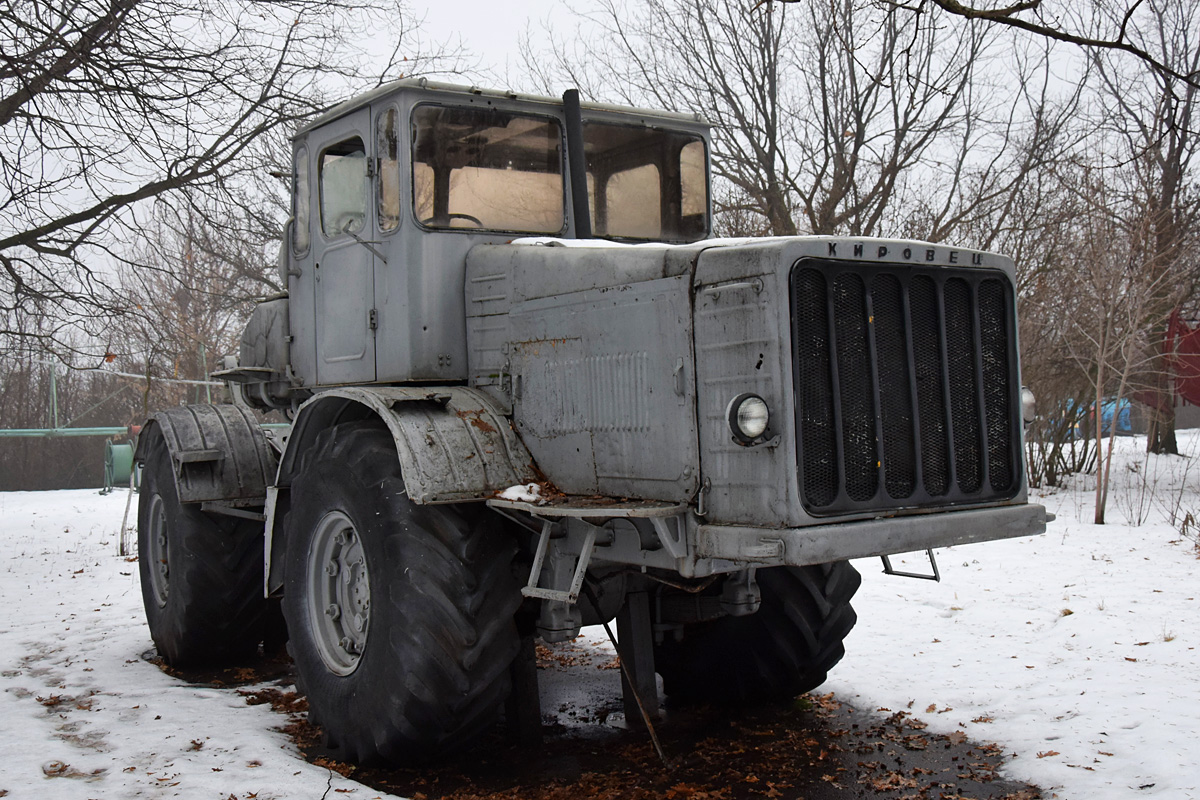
<box><xmin>157</xmin><ymin>642</ymin><xmax>1042</xmax><ymax>800</ymax></box>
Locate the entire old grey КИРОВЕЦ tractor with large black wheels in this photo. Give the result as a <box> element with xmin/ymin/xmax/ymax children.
<box><xmin>137</xmin><ymin>80</ymin><xmax>1048</xmax><ymax>762</ymax></box>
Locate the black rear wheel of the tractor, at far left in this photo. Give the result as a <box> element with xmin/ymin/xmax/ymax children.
<box><xmin>138</xmin><ymin>426</ymin><xmax>266</xmax><ymax>667</ymax></box>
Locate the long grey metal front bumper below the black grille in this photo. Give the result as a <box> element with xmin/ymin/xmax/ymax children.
<box><xmin>696</xmin><ymin>504</ymin><xmax>1054</xmax><ymax>566</ymax></box>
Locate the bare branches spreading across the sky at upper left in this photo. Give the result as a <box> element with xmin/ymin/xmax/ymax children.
<box><xmin>0</xmin><ymin>0</ymin><xmax>451</xmax><ymax>359</ymax></box>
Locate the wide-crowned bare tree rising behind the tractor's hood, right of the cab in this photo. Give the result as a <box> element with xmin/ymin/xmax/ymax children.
<box><xmin>524</xmin><ymin>0</ymin><xmax>1069</xmax><ymax>239</ymax></box>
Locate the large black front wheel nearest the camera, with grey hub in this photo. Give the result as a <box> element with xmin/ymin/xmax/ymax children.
<box><xmin>283</xmin><ymin>421</ymin><xmax>521</xmax><ymax>763</ymax></box>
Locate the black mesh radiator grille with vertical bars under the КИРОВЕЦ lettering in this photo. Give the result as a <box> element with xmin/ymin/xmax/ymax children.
<box><xmin>791</xmin><ymin>259</ymin><xmax>1020</xmax><ymax>515</ymax></box>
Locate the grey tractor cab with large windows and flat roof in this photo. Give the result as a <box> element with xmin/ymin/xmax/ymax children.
<box><xmin>261</xmin><ymin>79</ymin><xmax>710</xmax><ymax>398</ymax></box>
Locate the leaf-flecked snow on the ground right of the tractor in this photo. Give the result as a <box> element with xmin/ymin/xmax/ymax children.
<box><xmin>826</xmin><ymin>432</ymin><xmax>1200</xmax><ymax>800</ymax></box>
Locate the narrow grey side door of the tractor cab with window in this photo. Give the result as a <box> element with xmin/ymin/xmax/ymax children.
<box><xmin>310</xmin><ymin>108</ymin><xmax>376</xmax><ymax>385</ymax></box>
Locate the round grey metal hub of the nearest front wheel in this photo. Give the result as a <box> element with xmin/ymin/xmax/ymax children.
<box><xmin>307</xmin><ymin>511</ymin><xmax>371</xmax><ymax>675</ymax></box>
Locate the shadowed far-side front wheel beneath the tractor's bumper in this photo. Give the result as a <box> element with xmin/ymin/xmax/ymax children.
<box><xmin>654</xmin><ymin>561</ymin><xmax>862</xmax><ymax>705</ymax></box>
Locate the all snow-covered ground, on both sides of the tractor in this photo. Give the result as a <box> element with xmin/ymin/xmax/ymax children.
<box><xmin>0</xmin><ymin>435</ymin><xmax>1200</xmax><ymax>800</ymax></box>
